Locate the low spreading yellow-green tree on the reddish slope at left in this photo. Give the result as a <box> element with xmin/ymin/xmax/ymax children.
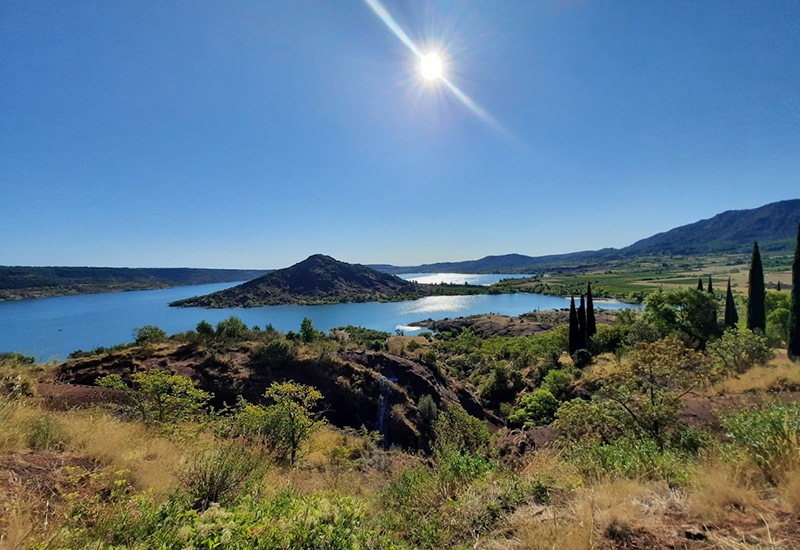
<box><xmin>97</xmin><ymin>369</ymin><xmax>214</xmax><ymax>422</ymax></box>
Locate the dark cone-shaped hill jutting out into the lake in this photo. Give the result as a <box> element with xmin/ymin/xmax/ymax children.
<box><xmin>170</xmin><ymin>254</ymin><xmax>422</xmax><ymax>308</ymax></box>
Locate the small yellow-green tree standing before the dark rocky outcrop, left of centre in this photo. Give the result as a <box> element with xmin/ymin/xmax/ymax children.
<box><xmin>264</xmin><ymin>381</ymin><xmax>323</xmax><ymax>465</ymax></box>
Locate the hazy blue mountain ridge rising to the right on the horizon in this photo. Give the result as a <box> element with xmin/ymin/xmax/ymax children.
<box><xmin>373</xmin><ymin>199</ymin><xmax>800</xmax><ymax>273</ymax></box>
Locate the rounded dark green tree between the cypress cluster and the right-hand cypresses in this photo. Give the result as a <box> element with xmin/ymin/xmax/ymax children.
<box><xmin>642</xmin><ymin>288</ymin><xmax>720</xmax><ymax>348</ymax></box>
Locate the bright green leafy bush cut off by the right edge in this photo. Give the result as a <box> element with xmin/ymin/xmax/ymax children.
<box><xmin>720</xmin><ymin>402</ymin><xmax>800</xmax><ymax>478</ymax></box>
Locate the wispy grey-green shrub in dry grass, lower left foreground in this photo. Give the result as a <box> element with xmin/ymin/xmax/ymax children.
<box><xmin>179</xmin><ymin>443</ymin><xmax>265</xmax><ymax>510</ymax></box>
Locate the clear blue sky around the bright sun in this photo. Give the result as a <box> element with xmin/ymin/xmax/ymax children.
<box><xmin>0</xmin><ymin>0</ymin><xmax>800</xmax><ymax>268</ymax></box>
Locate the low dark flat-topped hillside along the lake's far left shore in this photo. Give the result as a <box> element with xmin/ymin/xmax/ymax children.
<box><xmin>0</xmin><ymin>266</ymin><xmax>266</xmax><ymax>301</ymax></box>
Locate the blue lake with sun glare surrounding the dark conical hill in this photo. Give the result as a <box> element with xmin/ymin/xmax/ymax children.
<box><xmin>0</xmin><ymin>274</ymin><xmax>632</xmax><ymax>361</ymax></box>
